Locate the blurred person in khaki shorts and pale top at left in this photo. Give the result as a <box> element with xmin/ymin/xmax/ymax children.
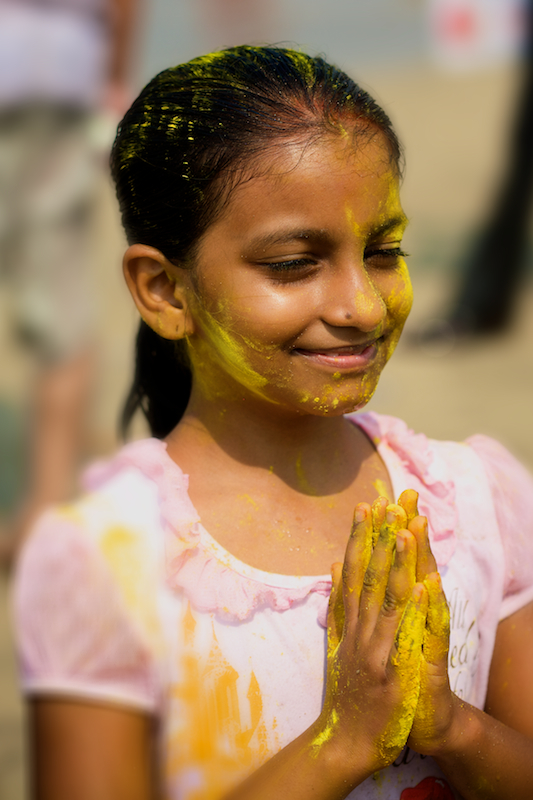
<box><xmin>0</xmin><ymin>0</ymin><xmax>137</xmax><ymax>563</ymax></box>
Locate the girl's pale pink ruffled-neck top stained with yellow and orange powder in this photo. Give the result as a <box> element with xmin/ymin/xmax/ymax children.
<box><xmin>14</xmin><ymin>413</ymin><xmax>533</xmax><ymax>800</ymax></box>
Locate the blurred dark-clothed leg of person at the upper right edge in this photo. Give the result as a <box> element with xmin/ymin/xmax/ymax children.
<box><xmin>416</xmin><ymin>0</ymin><xmax>533</xmax><ymax>342</ymax></box>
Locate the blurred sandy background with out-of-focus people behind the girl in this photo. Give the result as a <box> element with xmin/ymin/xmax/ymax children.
<box><xmin>0</xmin><ymin>0</ymin><xmax>533</xmax><ymax>800</ymax></box>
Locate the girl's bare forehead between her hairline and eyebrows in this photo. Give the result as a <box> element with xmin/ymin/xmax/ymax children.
<box><xmin>212</xmin><ymin>134</ymin><xmax>403</xmax><ymax>237</ymax></box>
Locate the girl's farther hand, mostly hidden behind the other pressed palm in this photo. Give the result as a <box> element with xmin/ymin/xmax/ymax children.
<box><xmin>398</xmin><ymin>490</ymin><xmax>457</xmax><ymax>755</ymax></box>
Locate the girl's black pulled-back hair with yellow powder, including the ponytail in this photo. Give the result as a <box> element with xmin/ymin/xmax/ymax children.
<box><xmin>111</xmin><ymin>46</ymin><xmax>401</xmax><ymax>438</ymax></box>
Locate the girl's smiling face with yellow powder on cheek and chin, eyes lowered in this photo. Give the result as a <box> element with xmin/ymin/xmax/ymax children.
<box><xmin>183</xmin><ymin>134</ymin><xmax>412</xmax><ymax>416</ymax></box>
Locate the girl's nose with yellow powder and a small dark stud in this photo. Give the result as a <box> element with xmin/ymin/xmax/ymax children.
<box><xmin>324</xmin><ymin>264</ymin><xmax>387</xmax><ymax>333</ymax></box>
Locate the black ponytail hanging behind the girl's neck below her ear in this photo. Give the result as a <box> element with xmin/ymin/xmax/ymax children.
<box><xmin>120</xmin><ymin>320</ymin><xmax>192</xmax><ymax>439</ymax></box>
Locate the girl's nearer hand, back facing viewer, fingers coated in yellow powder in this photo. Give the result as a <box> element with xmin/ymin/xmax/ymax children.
<box><xmin>320</xmin><ymin>499</ymin><xmax>427</xmax><ymax>774</ymax></box>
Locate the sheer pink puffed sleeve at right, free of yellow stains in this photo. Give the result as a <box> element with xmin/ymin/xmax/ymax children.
<box><xmin>467</xmin><ymin>435</ymin><xmax>533</xmax><ymax>620</ymax></box>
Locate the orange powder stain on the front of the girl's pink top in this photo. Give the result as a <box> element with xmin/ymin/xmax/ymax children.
<box><xmin>167</xmin><ymin>607</ymin><xmax>273</xmax><ymax>800</ymax></box>
